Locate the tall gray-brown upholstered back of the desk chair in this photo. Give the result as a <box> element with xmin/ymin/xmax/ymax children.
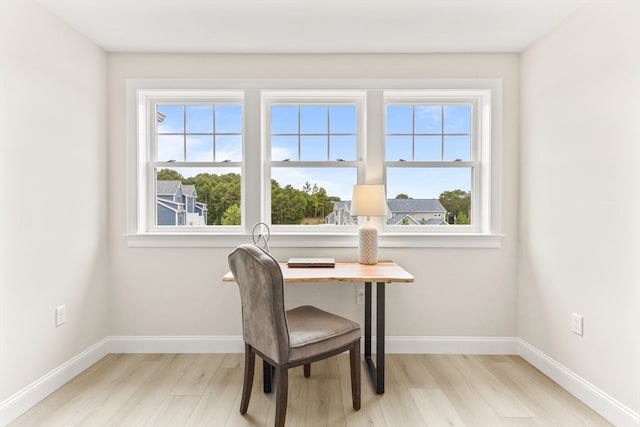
<box><xmin>229</xmin><ymin>244</ymin><xmax>289</xmax><ymax>363</ymax></box>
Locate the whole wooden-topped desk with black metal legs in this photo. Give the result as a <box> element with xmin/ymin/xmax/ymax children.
<box><xmin>222</xmin><ymin>261</ymin><xmax>413</xmax><ymax>394</ymax></box>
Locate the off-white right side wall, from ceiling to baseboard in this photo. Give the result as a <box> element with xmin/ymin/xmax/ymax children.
<box><xmin>518</xmin><ymin>0</ymin><xmax>640</xmax><ymax>413</ymax></box>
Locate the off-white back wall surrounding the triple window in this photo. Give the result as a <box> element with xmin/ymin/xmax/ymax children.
<box><xmin>108</xmin><ymin>54</ymin><xmax>519</xmax><ymax>337</ymax></box>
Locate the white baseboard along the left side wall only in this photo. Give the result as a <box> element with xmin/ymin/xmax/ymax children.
<box><xmin>0</xmin><ymin>338</ymin><xmax>109</xmax><ymax>426</ymax></box>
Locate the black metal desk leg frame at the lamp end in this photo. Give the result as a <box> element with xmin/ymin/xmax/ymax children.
<box><xmin>364</xmin><ymin>282</ymin><xmax>385</xmax><ymax>394</ymax></box>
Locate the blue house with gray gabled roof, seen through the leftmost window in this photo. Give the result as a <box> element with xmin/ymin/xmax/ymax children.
<box><xmin>156</xmin><ymin>180</ymin><xmax>207</xmax><ymax>225</ymax></box>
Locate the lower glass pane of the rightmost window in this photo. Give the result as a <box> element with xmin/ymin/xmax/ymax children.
<box><xmin>386</xmin><ymin>167</ymin><xmax>472</xmax><ymax>225</ymax></box>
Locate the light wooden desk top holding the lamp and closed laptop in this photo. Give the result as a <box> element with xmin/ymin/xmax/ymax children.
<box><xmin>222</xmin><ymin>261</ymin><xmax>413</xmax><ymax>283</ymax></box>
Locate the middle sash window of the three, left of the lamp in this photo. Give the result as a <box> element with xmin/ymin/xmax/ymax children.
<box><xmin>263</xmin><ymin>91</ymin><xmax>364</xmax><ymax>227</ymax></box>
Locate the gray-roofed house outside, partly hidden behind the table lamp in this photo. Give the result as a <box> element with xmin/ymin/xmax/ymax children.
<box><xmin>325</xmin><ymin>199</ymin><xmax>447</xmax><ymax>225</ymax></box>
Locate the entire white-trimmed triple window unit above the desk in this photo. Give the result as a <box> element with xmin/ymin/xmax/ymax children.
<box><xmin>127</xmin><ymin>79</ymin><xmax>501</xmax><ymax>247</ymax></box>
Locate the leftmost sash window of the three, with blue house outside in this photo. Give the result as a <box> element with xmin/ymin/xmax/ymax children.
<box><xmin>144</xmin><ymin>93</ymin><xmax>244</xmax><ymax>231</ymax></box>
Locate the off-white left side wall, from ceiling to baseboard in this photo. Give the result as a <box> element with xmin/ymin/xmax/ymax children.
<box><xmin>0</xmin><ymin>0</ymin><xmax>108</xmax><ymax>402</ymax></box>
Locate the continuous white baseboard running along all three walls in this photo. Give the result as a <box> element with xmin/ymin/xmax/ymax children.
<box><xmin>0</xmin><ymin>336</ymin><xmax>640</xmax><ymax>427</ymax></box>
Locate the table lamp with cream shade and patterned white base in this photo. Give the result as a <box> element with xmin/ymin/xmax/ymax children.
<box><xmin>351</xmin><ymin>184</ymin><xmax>387</xmax><ymax>264</ymax></box>
